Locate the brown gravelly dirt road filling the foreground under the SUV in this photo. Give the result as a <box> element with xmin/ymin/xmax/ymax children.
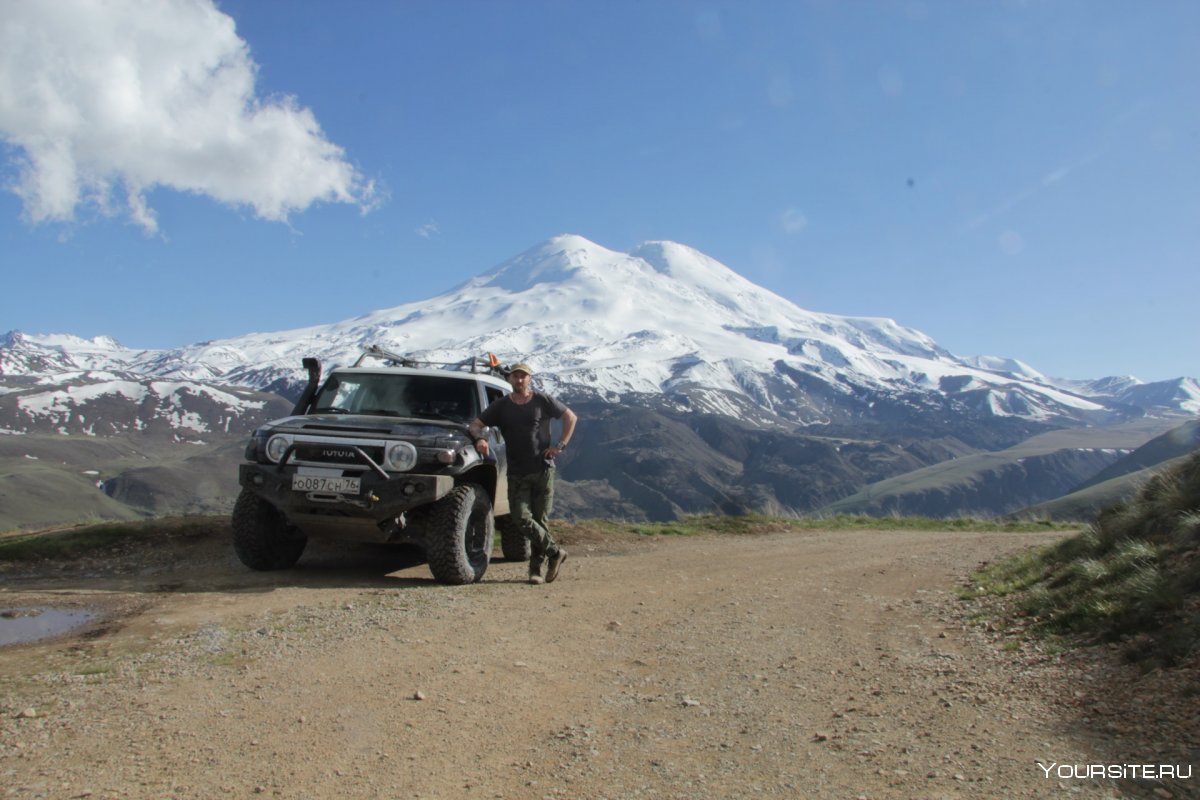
<box><xmin>0</xmin><ymin>522</ymin><xmax>1198</xmax><ymax>800</ymax></box>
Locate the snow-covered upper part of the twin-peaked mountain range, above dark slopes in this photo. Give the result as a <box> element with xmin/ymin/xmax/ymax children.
<box><xmin>0</xmin><ymin>235</ymin><xmax>1200</xmax><ymax>426</ymax></box>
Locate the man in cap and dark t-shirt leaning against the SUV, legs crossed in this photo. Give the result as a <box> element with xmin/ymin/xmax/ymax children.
<box><xmin>470</xmin><ymin>363</ymin><xmax>578</xmax><ymax>584</ymax></box>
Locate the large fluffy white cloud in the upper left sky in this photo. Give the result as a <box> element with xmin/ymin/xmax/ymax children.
<box><xmin>0</xmin><ymin>0</ymin><xmax>376</xmax><ymax>233</ymax></box>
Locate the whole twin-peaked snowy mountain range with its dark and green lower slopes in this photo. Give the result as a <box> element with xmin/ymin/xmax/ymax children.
<box><xmin>0</xmin><ymin>235</ymin><xmax>1200</xmax><ymax>528</ymax></box>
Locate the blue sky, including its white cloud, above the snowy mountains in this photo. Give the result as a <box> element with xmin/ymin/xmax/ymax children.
<box><xmin>0</xmin><ymin>0</ymin><xmax>1200</xmax><ymax>380</ymax></box>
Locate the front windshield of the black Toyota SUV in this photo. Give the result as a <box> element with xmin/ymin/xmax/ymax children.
<box><xmin>313</xmin><ymin>373</ymin><xmax>479</xmax><ymax>422</ymax></box>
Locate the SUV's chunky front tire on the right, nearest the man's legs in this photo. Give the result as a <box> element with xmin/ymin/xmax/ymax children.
<box><xmin>425</xmin><ymin>483</ymin><xmax>496</xmax><ymax>585</ymax></box>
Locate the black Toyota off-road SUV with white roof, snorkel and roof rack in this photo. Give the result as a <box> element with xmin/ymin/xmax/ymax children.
<box><xmin>233</xmin><ymin>347</ymin><xmax>529</xmax><ymax>584</ymax></box>
